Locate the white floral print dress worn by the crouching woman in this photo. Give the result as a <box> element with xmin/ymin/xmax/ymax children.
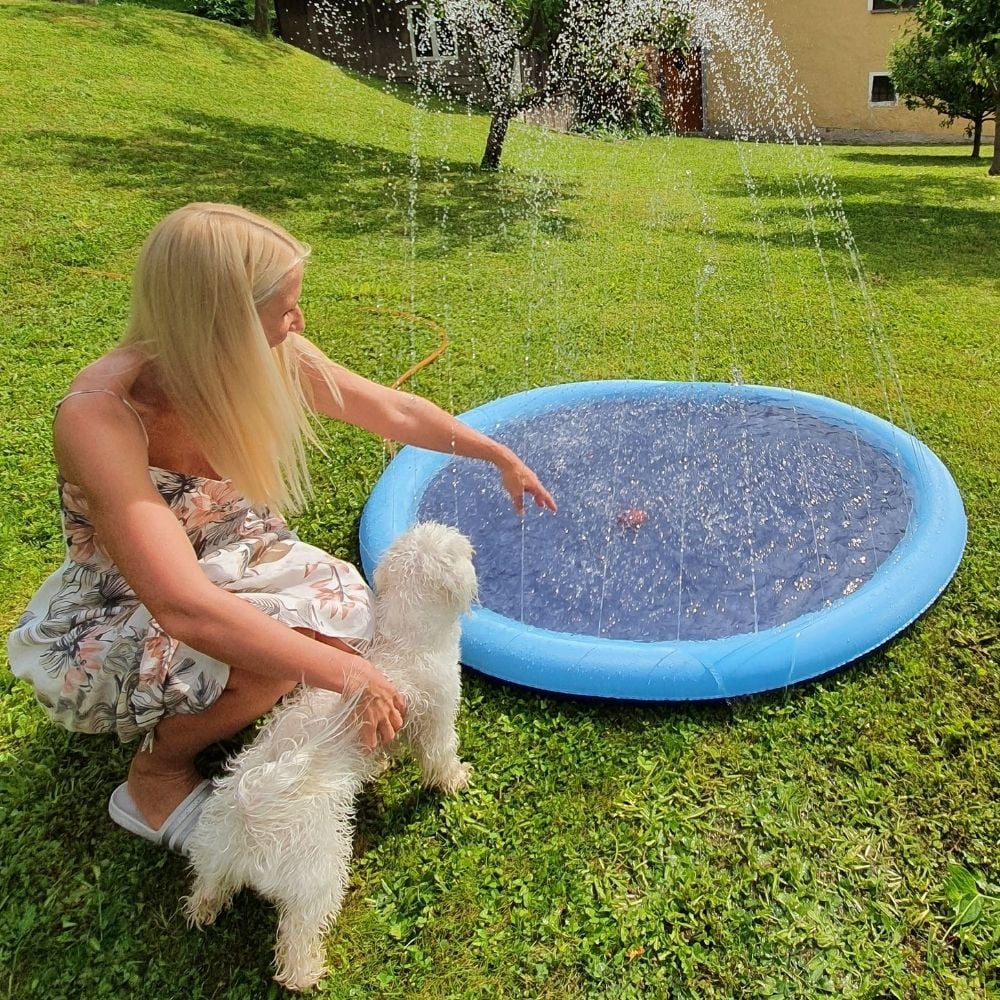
<box><xmin>7</xmin><ymin>397</ymin><xmax>373</xmax><ymax>741</ymax></box>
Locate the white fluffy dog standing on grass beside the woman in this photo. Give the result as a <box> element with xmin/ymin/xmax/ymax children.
<box><xmin>185</xmin><ymin>522</ymin><xmax>476</xmax><ymax>989</ymax></box>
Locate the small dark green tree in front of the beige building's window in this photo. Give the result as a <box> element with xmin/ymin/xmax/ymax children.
<box><xmin>889</xmin><ymin>34</ymin><xmax>996</xmax><ymax>159</ymax></box>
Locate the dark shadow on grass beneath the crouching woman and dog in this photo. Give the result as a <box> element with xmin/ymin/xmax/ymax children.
<box><xmin>0</xmin><ymin>704</ymin><xmax>454</xmax><ymax>1000</ymax></box>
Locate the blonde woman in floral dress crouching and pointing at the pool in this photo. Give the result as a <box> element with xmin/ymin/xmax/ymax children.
<box><xmin>8</xmin><ymin>204</ymin><xmax>555</xmax><ymax>851</ymax></box>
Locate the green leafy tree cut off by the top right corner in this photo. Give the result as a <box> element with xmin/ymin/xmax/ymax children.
<box><xmin>913</xmin><ymin>0</ymin><xmax>1000</xmax><ymax>177</ymax></box>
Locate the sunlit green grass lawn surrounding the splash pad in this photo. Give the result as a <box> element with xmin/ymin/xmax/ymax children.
<box><xmin>0</xmin><ymin>0</ymin><xmax>1000</xmax><ymax>1000</ymax></box>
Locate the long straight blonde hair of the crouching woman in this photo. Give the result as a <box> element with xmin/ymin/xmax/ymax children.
<box><xmin>123</xmin><ymin>203</ymin><xmax>336</xmax><ymax>511</ymax></box>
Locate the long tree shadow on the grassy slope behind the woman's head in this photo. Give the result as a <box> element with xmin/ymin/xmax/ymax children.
<box><xmin>19</xmin><ymin>112</ymin><xmax>573</xmax><ymax>258</ymax></box>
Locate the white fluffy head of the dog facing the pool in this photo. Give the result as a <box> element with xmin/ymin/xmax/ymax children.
<box><xmin>375</xmin><ymin>521</ymin><xmax>478</xmax><ymax>614</ymax></box>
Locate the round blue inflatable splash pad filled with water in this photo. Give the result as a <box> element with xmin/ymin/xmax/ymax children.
<box><xmin>361</xmin><ymin>381</ymin><xmax>966</xmax><ymax>700</ymax></box>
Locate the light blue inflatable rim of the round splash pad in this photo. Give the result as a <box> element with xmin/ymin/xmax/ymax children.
<box><xmin>360</xmin><ymin>380</ymin><xmax>967</xmax><ymax>701</ymax></box>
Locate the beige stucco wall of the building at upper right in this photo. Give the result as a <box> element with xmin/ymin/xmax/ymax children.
<box><xmin>705</xmin><ymin>0</ymin><xmax>992</xmax><ymax>142</ymax></box>
